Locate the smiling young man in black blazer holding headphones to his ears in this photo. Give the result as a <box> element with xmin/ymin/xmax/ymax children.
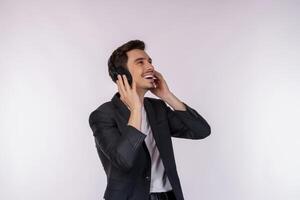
<box><xmin>89</xmin><ymin>40</ymin><xmax>211</xmax><ymax>200</ymax></box>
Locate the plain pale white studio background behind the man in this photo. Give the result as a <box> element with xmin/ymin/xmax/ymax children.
<box><xmin>0</xmin><ymin>0</ymin><xmax>300</xmax><ymax>200</ymax></box>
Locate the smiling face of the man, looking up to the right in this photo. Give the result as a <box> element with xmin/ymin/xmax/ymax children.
<box><xmin>127</xmin><ymin>49</ymin><xmax>154</xmax><ymax>89</ymax></box>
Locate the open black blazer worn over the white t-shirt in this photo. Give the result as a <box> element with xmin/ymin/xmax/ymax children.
<box><xmin>89</xmin><ymin>92</ymin><xmax>210</xmax><ymax>200</ymax></box>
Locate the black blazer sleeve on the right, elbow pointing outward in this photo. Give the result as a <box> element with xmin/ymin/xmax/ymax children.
<box><xmin>161</xmin><ymin>100</ymin><xmax>211</xmax><ymax>139</ymax></box>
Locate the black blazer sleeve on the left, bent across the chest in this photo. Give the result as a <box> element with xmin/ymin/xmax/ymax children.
<box><xmin>89</xmin><ymin>109</ymin><xmax>147</xmax><ymax>171</ymax></box>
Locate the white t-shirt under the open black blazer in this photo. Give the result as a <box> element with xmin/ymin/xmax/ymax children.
<box><xmin>141</xmin><ymin>106</ymin><xmax>172</xmax><ymax>192</ymax></box>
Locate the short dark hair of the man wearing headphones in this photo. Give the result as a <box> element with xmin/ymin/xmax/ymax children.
<box><xmin>107</xmin><ymin>40</ymin><xmax>145</xmax><ymax>82</ymax></box>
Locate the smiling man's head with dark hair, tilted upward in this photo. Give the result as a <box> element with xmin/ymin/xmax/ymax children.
<box><xmin>108</xmin><ymin>40</ymin><xmax>154</xmax><ymax>90</ymax></box>
